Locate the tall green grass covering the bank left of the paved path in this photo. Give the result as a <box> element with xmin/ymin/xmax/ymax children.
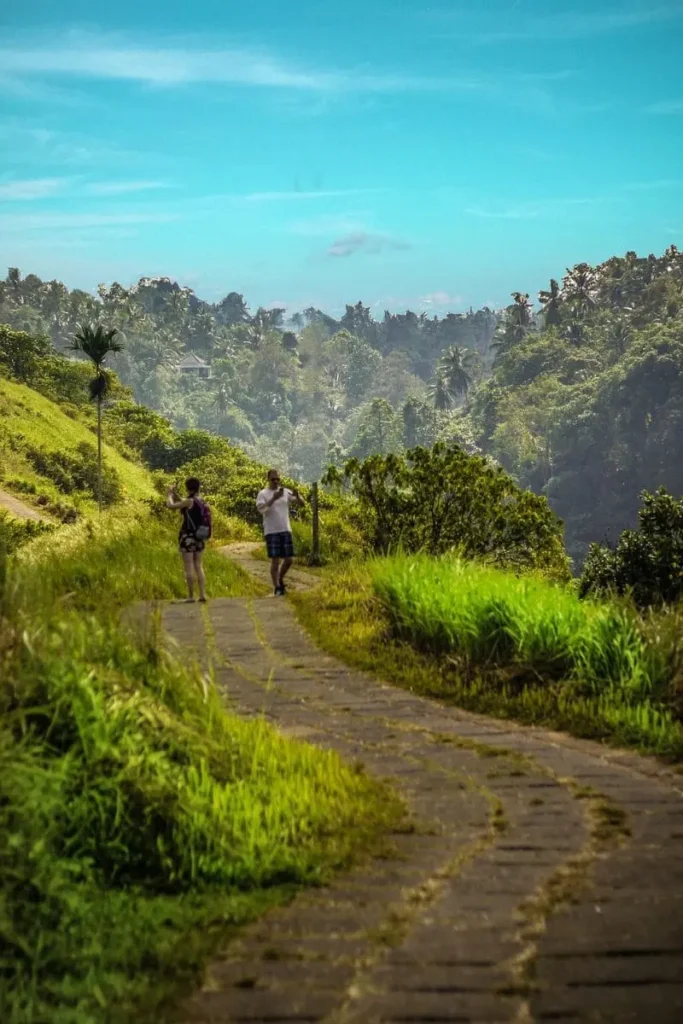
<box><xmin>0</xmin><ymin>516</ymin><xmax>399</xmax><ymax>1024</ymax></box>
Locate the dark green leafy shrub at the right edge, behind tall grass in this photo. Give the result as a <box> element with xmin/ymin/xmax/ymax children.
<box><xmin>580</xmin><ymin>487</ymin><xmax>683</xmax><ymax>608</ymax></box>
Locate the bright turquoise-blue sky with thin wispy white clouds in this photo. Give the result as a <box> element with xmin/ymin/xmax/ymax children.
<box><xmin>0</xmin><ymin>0</ymin><xmax>683</xmax><ymax>314</ymax></box>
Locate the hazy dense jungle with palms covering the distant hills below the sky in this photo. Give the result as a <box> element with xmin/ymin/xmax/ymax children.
<box><xmin>0</xmin><ymin>246</ymin><xmax>683</xmax><ymax>563</ymax></box>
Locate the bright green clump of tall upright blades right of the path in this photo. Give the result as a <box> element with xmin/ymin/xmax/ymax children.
<box><xmin>373</xmin><ymin>557</ymin><xmax>667</xmax><ymax>698</ymax></box>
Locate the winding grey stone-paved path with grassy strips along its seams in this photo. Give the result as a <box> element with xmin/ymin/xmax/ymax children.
<box><xmin>148</xmin><ymin>552</ymin><xmax>683</xmax><ymax>1024</ymax></box>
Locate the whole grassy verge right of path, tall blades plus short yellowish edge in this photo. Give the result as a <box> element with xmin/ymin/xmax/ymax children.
<box><xmin>295</xmin><ymin>557</ymin><xmax>683</xmax><ymax>760</ymax></box>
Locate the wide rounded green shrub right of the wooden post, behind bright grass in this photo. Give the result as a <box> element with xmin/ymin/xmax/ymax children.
<box><xmin>326</xmin><ymin>443</ymin><xmax>569</xmax><ymax>580</ymax></box>
